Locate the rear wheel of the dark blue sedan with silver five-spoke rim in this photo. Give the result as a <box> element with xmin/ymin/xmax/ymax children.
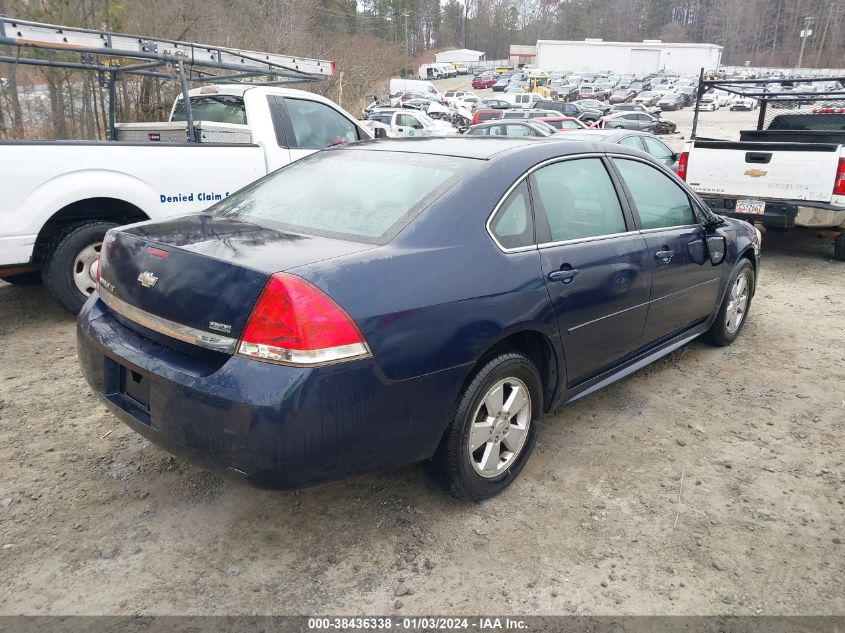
<box><xmin>427</xmin><ymin>352</ymin><xmax>543</xmax><ymax>501</ymax></box>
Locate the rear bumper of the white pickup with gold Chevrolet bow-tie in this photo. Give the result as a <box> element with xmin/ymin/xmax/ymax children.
<box><xmin>702</xmin><ymin>196</ymin><xmax>845</xmax><ymax>229</ymax></box>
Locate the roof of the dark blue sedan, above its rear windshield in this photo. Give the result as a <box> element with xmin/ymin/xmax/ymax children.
<box><xmin>340</xmin><ymin>136</ymin><xmax>643</xmax><ymax>160</ymax></box>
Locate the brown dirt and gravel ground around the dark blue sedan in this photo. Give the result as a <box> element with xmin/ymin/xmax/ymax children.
<box><xmin>0</xmin><ymin>86</ymin><xmax>845</xmax><ymax>615</ymax></box>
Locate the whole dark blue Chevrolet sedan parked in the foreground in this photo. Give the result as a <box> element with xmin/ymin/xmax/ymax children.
<box><xmin>78</xmin><ymin>138</ymin><xmax>760</xmax><ymax>499</ymax></box>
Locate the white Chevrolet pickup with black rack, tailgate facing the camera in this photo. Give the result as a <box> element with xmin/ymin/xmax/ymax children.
<box><xmin>678</xmin><ymin>82</ymin><xmax>845</xmax><ymax>260</ymax></box>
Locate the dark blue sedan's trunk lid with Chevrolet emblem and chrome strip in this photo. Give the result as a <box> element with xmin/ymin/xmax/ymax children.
<box><xmin>99</xmin><ymin>214</ymin><xmax>373</xmax><ymax>352</ymax></box>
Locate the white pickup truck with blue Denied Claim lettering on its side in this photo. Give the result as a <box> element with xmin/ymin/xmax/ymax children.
<box><xmin>0</xmin><ymin>84</ymin><xmax>373</xmax><ymax>312</ymax></box>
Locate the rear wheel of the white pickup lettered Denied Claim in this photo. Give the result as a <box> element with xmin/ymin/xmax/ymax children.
<box><xmin>41</xmin><ymin>221</ymin><xmax>118</xmax><ymax>314</ymax></box>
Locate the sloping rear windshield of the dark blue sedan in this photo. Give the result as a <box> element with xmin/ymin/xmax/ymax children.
<box><xmin>209</xmin><ymin>150</ymin><xmax>480</xmax><ymax>244</ymax></box>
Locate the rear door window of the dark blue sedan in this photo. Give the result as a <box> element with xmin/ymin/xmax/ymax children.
<box><xmin>532</xmin><ymin>158</ymin><xmax>627</xmax><ymax>242</ymax></box>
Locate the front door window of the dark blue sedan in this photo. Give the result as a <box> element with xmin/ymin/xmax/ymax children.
<box><xmin>613</xmin><ymin>158</ymin><xmax>696</xmax><ymax>229</ymax></box>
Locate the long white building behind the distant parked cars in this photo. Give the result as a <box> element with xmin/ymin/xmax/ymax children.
<box><xmin>537</xmin><ymin>39</ymin><xmax>722</xmax><ymax>75</ymax></box>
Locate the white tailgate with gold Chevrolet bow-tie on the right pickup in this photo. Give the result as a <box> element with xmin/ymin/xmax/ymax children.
<box><xmin>687</xmin><ymin>141</ymin><xmax>841</xmax><ymax>202</ymax></box>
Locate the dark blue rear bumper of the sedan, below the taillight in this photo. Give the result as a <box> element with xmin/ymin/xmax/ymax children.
<box><xmin>77</xmin><ymin>294</ymin><xmax>466</xmax><ymax>488</ymax></box>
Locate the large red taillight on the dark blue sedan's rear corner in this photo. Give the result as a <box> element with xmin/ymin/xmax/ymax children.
<box><xmin>238</xmin><ymin>273</ymin><xmax>370</xmax><ymax>365</ymax></box>
